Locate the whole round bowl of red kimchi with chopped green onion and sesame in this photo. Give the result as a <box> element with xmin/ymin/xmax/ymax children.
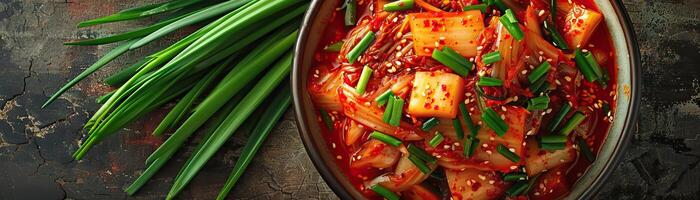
<box><xmin>292</xmin><ymin>0</ymin><xmax>641</xmax><ymax>199</ymax></box>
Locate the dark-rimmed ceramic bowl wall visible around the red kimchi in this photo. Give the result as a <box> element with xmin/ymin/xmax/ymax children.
<box><xmin>291</xmin><ymin>0</ymin><xmax>641</xmax><ymax>199</ymax></box>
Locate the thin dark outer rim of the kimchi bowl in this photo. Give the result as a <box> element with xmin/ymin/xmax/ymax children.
<box><xmin>290</xmin><ymin>0</ymin><xmax>642</xmax><ymax>199</ymax></box>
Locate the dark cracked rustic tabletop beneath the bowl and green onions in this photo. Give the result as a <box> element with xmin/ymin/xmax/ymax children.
<box><xmin>0</xmin><ymin>0</ymin><xmax>700</xmax><ymax>199</ymax></box>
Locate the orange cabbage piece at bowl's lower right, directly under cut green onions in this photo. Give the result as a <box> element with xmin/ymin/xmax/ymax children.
<box><xmin>525</xmin><ymin>139</ymin><xmax>576</xmax><ymax>176</ymax></box>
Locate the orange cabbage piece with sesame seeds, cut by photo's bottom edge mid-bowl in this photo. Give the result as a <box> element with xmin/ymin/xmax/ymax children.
<box><xmin>445</xmin><ymin>169</ymin><xmax>506</xmax><ymax>200</ymax></box>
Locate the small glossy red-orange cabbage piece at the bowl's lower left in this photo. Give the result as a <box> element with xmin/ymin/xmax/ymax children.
<box><xmin>350</xmin><ymin>139</ymin><xmax>401</xmax><ymax>169</ymax></box>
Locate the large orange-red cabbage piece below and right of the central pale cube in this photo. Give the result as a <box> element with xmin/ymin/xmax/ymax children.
<box><xmin>434</xmin><ymin>106</ymin><xmax>529</xmax><ymax>172</ymax></box>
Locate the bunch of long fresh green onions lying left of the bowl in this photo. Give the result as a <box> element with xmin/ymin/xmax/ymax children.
<box><xmin>44</xmin><ymin>0</ymin><xmax>308</xmax><ymax>199</ymax></box>
